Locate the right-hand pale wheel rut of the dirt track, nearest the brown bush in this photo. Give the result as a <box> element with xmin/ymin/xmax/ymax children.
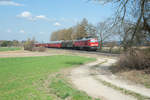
<box><xmin>94</xmin><ymin>59</ymin><xmax>150</xmax><ymax>98</ymax></box>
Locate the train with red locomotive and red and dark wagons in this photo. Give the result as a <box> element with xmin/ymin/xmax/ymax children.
<box><xmin>35</xmin><ymin>38</ymin><xmax>99</xmax><ymax>51</ymax></box>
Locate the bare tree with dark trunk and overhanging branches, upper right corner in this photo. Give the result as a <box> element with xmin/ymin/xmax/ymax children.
<box><xmin>94</xmin><ymin>0</ymin><xmax>150</xmax><ymax>46</ymax></box>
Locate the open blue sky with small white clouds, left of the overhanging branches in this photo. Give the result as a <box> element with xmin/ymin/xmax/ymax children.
<box><xmin>0</xmin><ymin>0</ymin><xmax>113</xmax><ymax>42</ymax></box>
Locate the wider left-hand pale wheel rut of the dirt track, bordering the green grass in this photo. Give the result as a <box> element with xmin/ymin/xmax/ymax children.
<box><xmin>70</xmin><ymin>58</ymin><xmax>136</xmax><ymax>100</ymax></box>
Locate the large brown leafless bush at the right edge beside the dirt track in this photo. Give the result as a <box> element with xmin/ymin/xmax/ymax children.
<box><xmin>117</xmin><ymin>49</ymin><xmax>150</xmax><ymax>70</ymax></box>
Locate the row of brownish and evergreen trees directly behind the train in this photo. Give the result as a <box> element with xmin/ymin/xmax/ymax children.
<box><xmin>50</xmin><ymin>18</ymin><xmax>96</xmax><ymax>41</ymax></box>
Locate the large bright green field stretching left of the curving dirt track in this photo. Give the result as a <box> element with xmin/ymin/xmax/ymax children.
<box><xmin>0</xmin><ymin>56</ymin><xmax>94</xmax><ymax>100</ymax></box>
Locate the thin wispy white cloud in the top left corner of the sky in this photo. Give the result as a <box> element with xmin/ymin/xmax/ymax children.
<box><xmin>0</xmin><ymin>0</ymin><xmax>23</xmax><ymax>6</ymax></box>
